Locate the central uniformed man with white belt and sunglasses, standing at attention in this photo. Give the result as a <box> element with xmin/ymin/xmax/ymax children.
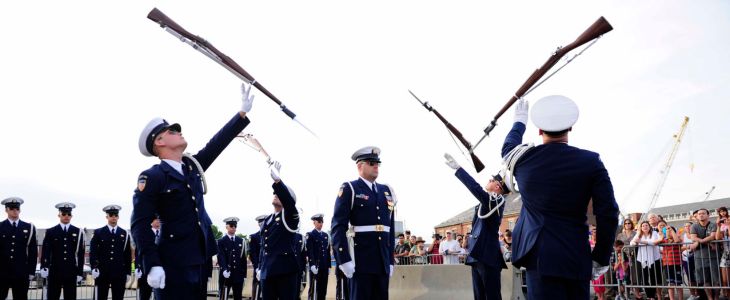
<box><xmin>332</xmin><ymin>147</ymin><xmax>396</xmax><ymax>299</ymax></box>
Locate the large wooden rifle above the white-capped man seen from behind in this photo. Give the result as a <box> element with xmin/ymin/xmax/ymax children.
<box><xmin>469</xmin><ymin>17</ymin><xmax>613</xmax><ymax>152</ymax></box>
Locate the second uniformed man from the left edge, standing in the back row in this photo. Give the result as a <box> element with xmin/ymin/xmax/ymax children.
<box><xmin>41</xmin><ymin>202</ymin><xmax>86</xmax><ymax>300</ymax></box>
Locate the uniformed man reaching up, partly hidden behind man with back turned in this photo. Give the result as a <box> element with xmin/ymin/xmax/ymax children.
<box><xmin>444</xmin><ymin>153</ymin><xmax>510</xmax><ymax>300</ymax></box>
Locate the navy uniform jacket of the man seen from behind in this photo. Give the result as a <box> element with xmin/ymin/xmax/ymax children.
<box><xmin>502</xmin><ymin>122</ymin><xmax>618</xmax><ymax>280</ymax></box>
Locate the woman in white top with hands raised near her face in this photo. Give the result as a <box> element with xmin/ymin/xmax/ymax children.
<box><xmin>631</xmin><ymin>219</ymin><xmax>662</xmax><ymax>299</ymax></box>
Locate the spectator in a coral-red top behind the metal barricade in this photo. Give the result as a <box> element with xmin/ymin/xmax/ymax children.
<box><xmin>657</xmin><ymin>220</ymin><xmax>684</xmax><ymax>300</ymax></box>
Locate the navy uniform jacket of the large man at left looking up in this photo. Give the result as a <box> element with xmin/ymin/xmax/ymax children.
<box><xmin>132</xmin><ymin>113</ymin><xmax>249</xmax><ymax>274</ymax></box>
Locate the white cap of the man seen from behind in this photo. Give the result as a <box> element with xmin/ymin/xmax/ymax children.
<box><xmin>531</xmin><ymin>95</ymin><xmax>579</xmax><ymax>132</ymax></box>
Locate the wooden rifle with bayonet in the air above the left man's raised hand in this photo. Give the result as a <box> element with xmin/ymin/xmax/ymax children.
<box><xmin>147</xmin><ymin>8</ymin><xmax>317</xmax><ymax>137</ymax></box>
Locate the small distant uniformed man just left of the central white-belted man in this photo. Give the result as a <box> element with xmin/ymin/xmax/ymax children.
<box><xmin>307</xmin><ymin>214</ymin><xmax>332</xmax><ymax>300</ymax></box>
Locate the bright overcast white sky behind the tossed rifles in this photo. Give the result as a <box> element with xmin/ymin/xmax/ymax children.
<box><xmin>0</xmin><ymin>1</ymin><xmax>730</xmax><ymax>237</ymax></box>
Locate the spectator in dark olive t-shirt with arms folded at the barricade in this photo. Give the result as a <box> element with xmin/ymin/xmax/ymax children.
<box><xmin>690</xmin><ymin>208</ymin><xmax>720</xmax><ymax>300</ymax></box>
